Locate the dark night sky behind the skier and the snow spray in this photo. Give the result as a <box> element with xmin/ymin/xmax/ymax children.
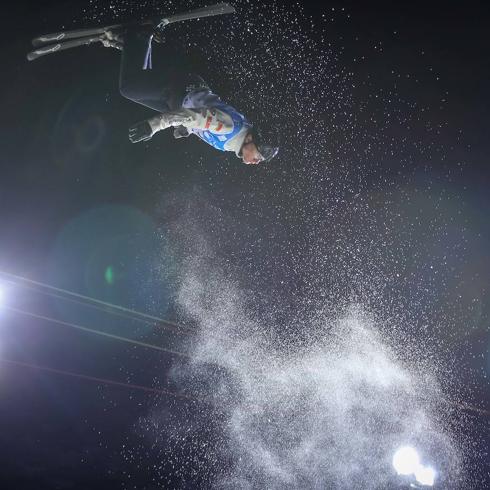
<box><xmin>0</xmin><ymin>1</ymin><xmax>490</xmax><ymax>489</ymax></box>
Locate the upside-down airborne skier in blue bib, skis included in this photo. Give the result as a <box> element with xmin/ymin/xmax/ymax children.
<box><xmin>28</xmin><ymin>4</ymin><xmax>279</xmax><ymax>164</ymax></box>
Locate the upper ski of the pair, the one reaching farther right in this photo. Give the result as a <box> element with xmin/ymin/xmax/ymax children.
<box><xmin>32</xmin><ymin>3</ymin><xmax>235</xmax><ymax>47</ymax></box>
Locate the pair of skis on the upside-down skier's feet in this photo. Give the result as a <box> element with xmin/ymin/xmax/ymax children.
<box><xmin>27</xmin><ymin>3</ymin><xmax>235</xmax><ymax>61</ymax></box>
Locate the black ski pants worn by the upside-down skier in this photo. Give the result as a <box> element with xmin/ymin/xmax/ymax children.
<box><xmin>119</xmin><ymin>28</ymin><xmax>206</xmax><ymax>112</ymax></box>
